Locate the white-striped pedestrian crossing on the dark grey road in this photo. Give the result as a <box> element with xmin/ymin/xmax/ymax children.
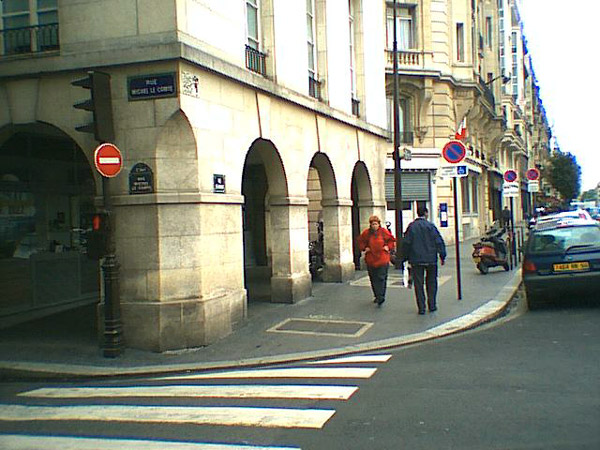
<box><xmin>0</xmin><ymin>354</ymin><xmax>391</xmax><ymax>450</ymax></box>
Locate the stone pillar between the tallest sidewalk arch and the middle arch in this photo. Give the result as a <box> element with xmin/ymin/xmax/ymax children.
<box><xmin>269</xmin><ymin>196</ymin><xmax>312</xmax><ymax>303</ymax></box>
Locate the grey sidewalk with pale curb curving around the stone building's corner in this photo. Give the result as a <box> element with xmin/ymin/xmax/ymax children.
<box><xmin>0</xmin><ymin>240</ymin><xmax>521</xmax><ymax>378</ymax></box>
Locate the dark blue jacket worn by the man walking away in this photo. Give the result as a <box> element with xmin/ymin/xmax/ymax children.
<box><xmin>402</xmin><ymin>217</ymin><xmax>446</xmax><ymax>264</ymax></box>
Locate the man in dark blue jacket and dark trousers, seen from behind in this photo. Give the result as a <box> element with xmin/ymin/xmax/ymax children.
<box><xmin>403</xmin><ymin>206</ymin><xmax>446</xmax><ymax>315</ymax></box>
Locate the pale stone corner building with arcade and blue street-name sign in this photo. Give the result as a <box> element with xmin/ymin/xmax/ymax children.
<box><xmin>0</xmin><ymin>0</ymin><xmax>390</xmax><ymax>351</ymax></box>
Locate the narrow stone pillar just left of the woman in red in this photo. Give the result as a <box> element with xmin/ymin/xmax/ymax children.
<box><xmin>321</xmin><ymin>199</ymin><xmax>354</xmax><ymax>282</ymax></box>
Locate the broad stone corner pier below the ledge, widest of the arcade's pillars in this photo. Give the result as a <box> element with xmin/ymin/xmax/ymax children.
<box><xmin>114</xmin><ymin>193</ymin><xmax>247</xmax><ymax>352</ymax></box>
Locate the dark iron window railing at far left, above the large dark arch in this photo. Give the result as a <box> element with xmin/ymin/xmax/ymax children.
<box><xmin>0</xmin><ymin>23</ymin><xmax>60</xmax><ymax>55</ymax></box>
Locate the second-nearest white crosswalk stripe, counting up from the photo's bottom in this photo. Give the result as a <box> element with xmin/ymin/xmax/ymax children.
<box><xmin>0</xmin><ymin>405</ymin><xmax>335</xmax><ymax>428</ymax></box>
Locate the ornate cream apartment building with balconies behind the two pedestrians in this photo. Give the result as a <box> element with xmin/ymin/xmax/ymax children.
<box><xmin>386</xmin><ymin>0</ymin><xmax>549</xmax><ymax>242</ymax></box>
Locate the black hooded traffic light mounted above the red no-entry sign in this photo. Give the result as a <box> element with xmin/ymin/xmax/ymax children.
<box><xmin>71</xmin><ymin>71</ymin><xmax>115</xmax><ymax>142</ymax></box>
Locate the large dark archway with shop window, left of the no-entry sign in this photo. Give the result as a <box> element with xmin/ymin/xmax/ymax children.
<box><xmin>0</xmin><ymin>122</ymin><xmax>99</xmax><ymax>326</ymax></box>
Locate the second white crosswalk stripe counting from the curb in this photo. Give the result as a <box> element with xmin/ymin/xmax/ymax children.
<box><xmin>151</xmin><ymin>367</ymin><xmax>377</xmax><ymax>380</ymax></box>
